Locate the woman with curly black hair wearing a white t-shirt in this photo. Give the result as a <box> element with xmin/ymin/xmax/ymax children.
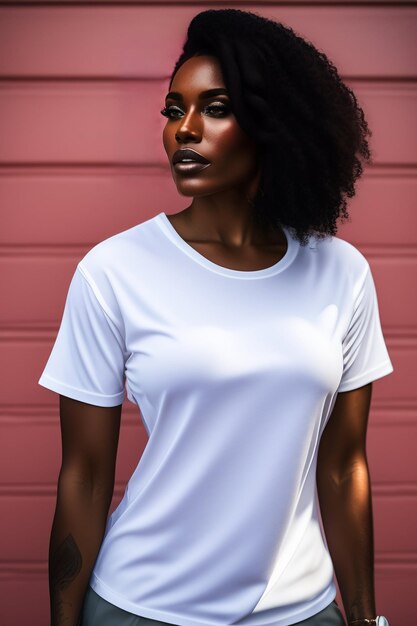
<box><xmin>39</xmin><ymin>9</ymin><xmax>393</xmax><ymax>626</ymax></box>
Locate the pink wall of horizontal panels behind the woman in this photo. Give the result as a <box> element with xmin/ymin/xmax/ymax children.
<box><xmin>0</xmin><ymin>1</ymin><xmax>417</xmax><ymax>626</ymax></box>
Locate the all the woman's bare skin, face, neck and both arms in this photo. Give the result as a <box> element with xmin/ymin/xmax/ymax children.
<box><xmin>49</xmin><ymin>55</ymin><xmax>376</xmax><ymax>626</ymax></box>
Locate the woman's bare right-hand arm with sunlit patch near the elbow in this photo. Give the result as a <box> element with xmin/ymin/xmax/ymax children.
<box><xmin>316</xmin><ymin>383</ymin><xmax>377</xmax><ymax>622</ymax></box>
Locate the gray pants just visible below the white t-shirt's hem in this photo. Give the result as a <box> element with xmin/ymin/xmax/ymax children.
<box><xmin>80</xmin><ymin>585</ymin><xmax>345</xmax><ymax>626</ymax></box>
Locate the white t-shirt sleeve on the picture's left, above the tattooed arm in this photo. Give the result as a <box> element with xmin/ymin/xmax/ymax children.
<box><xmin>38</xmin><ymin>265</ymin><xmax>126</xmax><ymax>406</ymax></box>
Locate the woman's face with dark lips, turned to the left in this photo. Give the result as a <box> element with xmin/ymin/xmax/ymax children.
<box><xmin>163</xmin><ymin>55</ymin><xmax>259</xmax><ymax>197</ymax></box>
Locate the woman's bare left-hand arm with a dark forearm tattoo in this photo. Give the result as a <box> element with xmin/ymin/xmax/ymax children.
<box><xmin>49</xmin><ymin>395</ymin><xmax>122</xmax><ymax>626</ymax></box>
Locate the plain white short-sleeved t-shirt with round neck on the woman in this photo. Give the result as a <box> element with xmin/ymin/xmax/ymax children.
<box><xmin>39</xmin><ymin>213</ymin><xmax>393</xmax><ymax>626</ymax></box>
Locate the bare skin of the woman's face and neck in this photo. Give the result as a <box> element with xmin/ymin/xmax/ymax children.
<box><xmin>163</xmin><ymin>55</ymin><xmax>287</xmax><ymax>270</ymax></box>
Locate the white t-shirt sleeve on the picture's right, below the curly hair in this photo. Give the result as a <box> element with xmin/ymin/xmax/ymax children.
<box><xmin>337</xmin><ymin>265</ymin><xmax>394</xmax><ymax>391</ymax></box>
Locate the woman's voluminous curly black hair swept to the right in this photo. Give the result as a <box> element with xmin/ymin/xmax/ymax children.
<box><xmin>170</xmin><ymin>9</ymin><xmax>372</xmax><ymax>245</ymax></box>
